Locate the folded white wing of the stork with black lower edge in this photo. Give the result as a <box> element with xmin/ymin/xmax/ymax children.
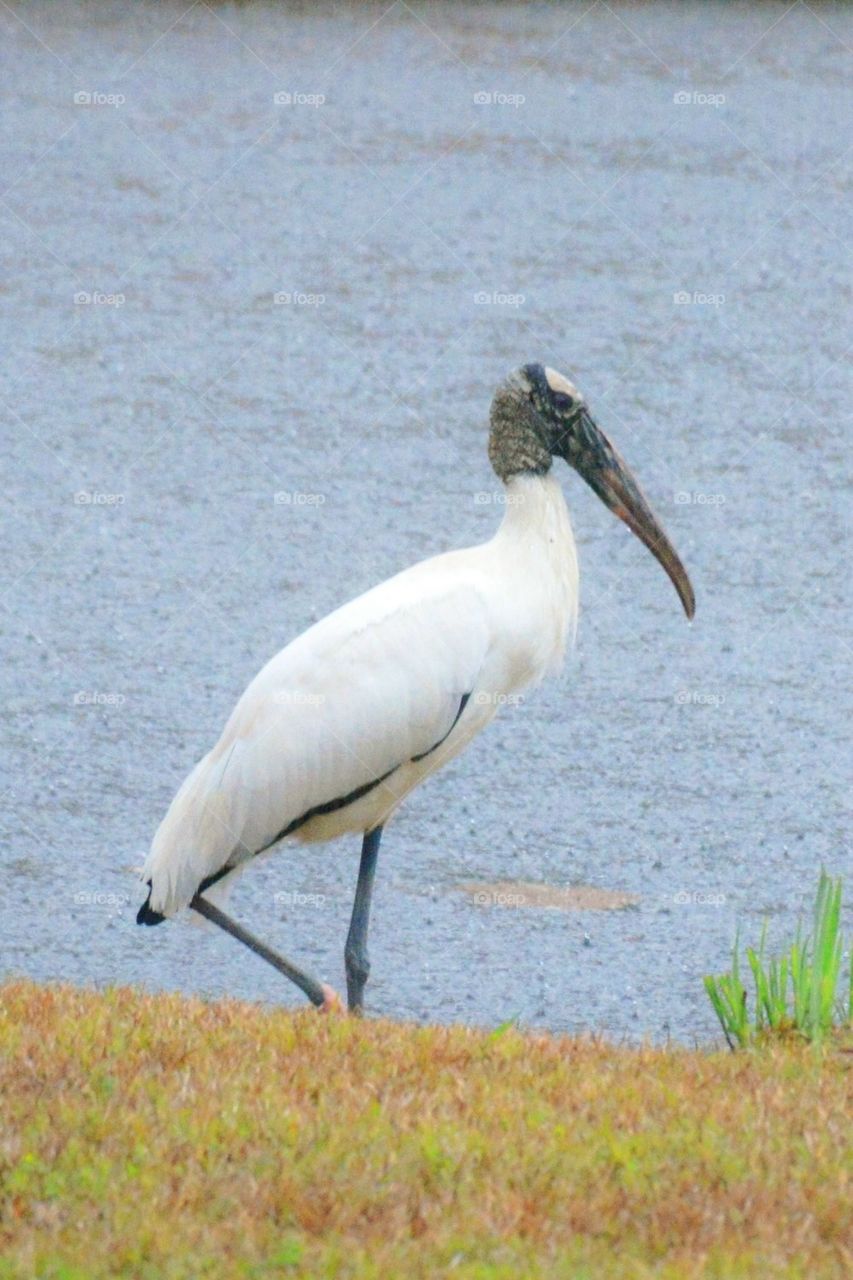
<box><xmin>143</xmin><ymin>553</ymin><xmax>493</xmax><ymax>914</ymax></box>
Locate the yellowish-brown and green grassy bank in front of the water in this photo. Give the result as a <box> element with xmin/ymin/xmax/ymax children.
<box><xmin>0</xmin><ymin>983</ymin><xmax>853</xmax><ymax>1280</ymax></box>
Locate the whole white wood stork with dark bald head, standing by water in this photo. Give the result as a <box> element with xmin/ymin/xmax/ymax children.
<box><xmin>137</xmin><ymin>364</ymin><xmax>694</xmax><ymax>1011</ymax></box>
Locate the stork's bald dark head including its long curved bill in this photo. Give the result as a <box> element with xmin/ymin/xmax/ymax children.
<box><xmin>489</xmin><ymin>365</ymin><xmax>695</xmax><ymax>618</ymax></box>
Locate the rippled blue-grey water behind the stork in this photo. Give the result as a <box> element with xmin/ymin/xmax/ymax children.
<box><xmin>0</xmin><ymin>3</ymin><xmax>853</xmax><ymax>1041</ymax></box>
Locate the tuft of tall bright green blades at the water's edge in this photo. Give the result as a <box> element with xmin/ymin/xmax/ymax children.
<box><xmin>704</xmin><ymin>870</ymin><xmax>853</xmax><ymax>1048</ymax></box>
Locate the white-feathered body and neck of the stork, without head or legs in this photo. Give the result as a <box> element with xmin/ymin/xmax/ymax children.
<box><xmin>142</xmin><ymin>472</ymin><xmax>578</xmax><ymax>915</ymax></box>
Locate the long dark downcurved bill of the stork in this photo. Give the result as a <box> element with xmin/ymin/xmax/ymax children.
<box><xmin>561</xmin><ymin>408</ymin><xmax>695</xmax><ymax>618</ymax></box>
